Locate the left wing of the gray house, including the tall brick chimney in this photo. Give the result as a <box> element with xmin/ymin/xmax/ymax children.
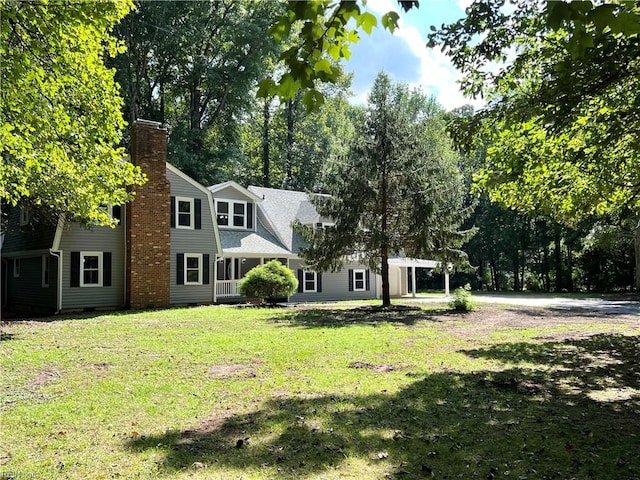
<box><xmin>2</xmin><ymin>121</ymin><xmax>221</xmax><ymax>313</ymax></box>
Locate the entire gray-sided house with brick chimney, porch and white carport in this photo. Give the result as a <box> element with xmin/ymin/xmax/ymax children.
<box><xmin>0</xmin><ymin>120</ymin><xmax>436</xmax><ymax>313</ymax></box>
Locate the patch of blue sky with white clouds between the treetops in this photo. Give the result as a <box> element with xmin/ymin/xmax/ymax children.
<box><xmin>345</xmin><ymin>0</ymin><xmax>483</xmax><ymax>110</ymax></box>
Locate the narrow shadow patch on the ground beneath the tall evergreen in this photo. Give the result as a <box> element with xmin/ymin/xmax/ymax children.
<box><xmin>273</xmin><ymin>305</ymin><xmax>459</xmax><ymax>328</ymax></box>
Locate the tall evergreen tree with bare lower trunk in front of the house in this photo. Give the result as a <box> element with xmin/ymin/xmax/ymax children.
<box><xmin>298</xmin><ymin>73</ymin><xmax>473</xmax><ymax>307</ymax></box>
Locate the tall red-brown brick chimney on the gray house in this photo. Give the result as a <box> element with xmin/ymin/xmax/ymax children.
<box><xmin>126</xmin><ymin>120</ymin><xmax>171</xmax><ymax>309</ymax></box>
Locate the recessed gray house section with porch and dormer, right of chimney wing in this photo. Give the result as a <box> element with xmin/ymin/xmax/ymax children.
<box><xmin>209</xmin><ymin>182</ymin><xmax>380</xmax><ymax>302</ymax></box>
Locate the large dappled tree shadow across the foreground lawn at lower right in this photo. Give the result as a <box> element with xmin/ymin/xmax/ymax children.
<box><xmin>127</xmin><ymin>335</ymin><xmax>640</xmax><ymax>479</ymax></box>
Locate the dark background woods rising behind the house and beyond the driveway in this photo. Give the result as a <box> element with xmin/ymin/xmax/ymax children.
<box><xmin>105</xmin><ymin>0</ymin><xmax>634</xmax><ymax>291</ymax></box>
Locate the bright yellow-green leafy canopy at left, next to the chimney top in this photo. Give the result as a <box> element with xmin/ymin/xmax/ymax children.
<box><xmin>0</xmin><ymin>0</ymin><xmax>145</xmax><ymax>224</ymax></box>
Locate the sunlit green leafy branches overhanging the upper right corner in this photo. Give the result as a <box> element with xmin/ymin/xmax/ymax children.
<box><xmin>430</xmin><ymin>0</ymin><xmax>640</xmax><ymax>224</ymax></box>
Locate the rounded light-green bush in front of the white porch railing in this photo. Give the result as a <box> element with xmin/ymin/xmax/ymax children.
<box><xmin>238</xmin><ymin>260</ymin><xmax>298</xmax><ymax>305</ymax></box>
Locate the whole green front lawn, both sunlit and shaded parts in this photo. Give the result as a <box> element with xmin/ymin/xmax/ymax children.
<box><xmin>0</xmin><ymin>305</ymin><xmax>640</xmax><ymax>479</ymax></box>
